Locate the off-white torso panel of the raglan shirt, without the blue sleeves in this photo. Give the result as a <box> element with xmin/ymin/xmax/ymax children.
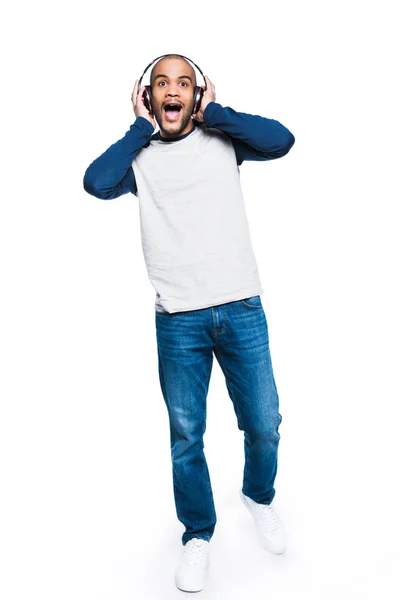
<box><xmin>132</xmin><ymin>127</ymin><xmax>264</xmax><ymax>313</ymax></box>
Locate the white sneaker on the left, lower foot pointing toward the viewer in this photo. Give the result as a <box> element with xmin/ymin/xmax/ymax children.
<box><xmin>175</xmin><ymin>537</ymin><xmax>209</xmax><ymax>592</ymax></box>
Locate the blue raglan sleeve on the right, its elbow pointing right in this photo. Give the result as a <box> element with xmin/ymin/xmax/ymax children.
<box><xmin>203</xmin><ymin>102</ymin><xmax>295</xmax><ymax>165</ymax></box>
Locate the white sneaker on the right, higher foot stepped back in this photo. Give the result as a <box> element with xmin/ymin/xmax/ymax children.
<box><xmin>240</xmin><ymin>490</ymin><xmax>287</xmax><ymax>554</ymax></box>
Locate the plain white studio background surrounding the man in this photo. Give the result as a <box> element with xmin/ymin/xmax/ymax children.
<box><xmin>0</xmin><ymin>0</ymin><xmax>400</xmax><ymax>600</ymax></box>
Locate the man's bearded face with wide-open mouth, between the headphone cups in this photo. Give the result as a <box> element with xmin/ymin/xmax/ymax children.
<box><xmin>151</xmin><ymin>58</ymin><xmax>196</xmax><ymax>138</ymax></box>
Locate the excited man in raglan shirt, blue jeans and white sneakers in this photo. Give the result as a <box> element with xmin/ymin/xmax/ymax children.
<box><xmin>84</xmin><ymin>55</ymin><xmax>294</xmax><ymax>592</ymax></box>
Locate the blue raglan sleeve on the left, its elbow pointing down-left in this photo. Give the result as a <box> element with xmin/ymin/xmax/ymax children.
<box><xmin>83</xmin><ymin>117</ymin><xmax>154</xmax><ymax>200</ymax></box>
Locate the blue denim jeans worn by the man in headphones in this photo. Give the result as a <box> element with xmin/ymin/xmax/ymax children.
<box><xmin>155</xmin><ymin>296</ymin><xmax>282</xmax><ymax>545</ymax></box>
